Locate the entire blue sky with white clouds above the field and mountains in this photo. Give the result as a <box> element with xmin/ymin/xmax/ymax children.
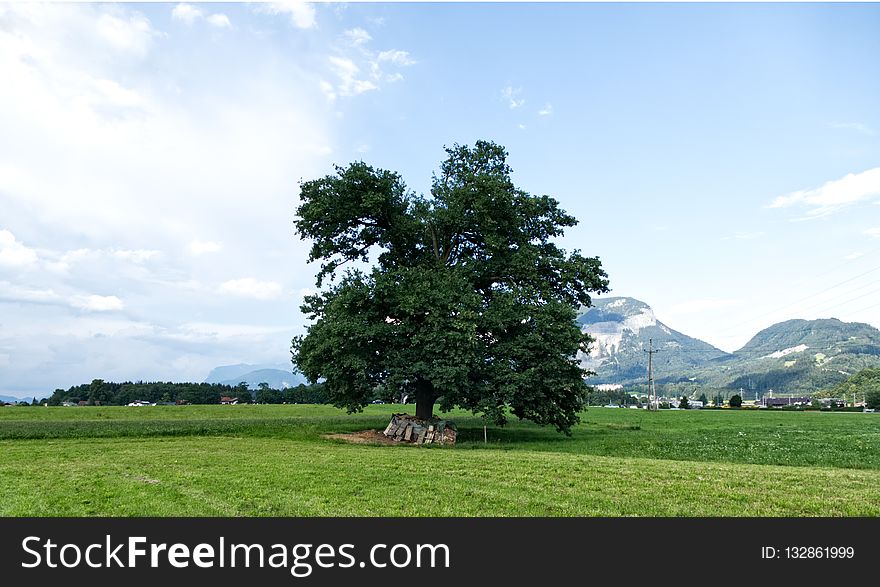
<box><xmin>0</xmin><ymin>2</ymin><xmax>880</xmax><ymax>397</ymax></box>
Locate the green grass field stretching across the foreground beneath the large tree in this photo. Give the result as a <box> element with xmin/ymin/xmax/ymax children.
<box><xmin>0</xmin><ymin>405</ymin><xmax>880</xmax><ymax>516</ymax></box>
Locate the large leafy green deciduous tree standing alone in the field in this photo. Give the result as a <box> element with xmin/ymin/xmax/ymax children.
<box><xmin>292</xmin><ymin>141</ymin><xmax>608</xmax><ymax>432</ymax></box>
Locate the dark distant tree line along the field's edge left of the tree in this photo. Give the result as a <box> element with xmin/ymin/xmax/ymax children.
<box><xmin>46</xmin><ymin>379</ymin><xmax>327</xmax><ymax>406</ymax></box>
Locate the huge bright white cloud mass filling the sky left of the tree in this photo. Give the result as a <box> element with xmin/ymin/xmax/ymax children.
<box><xmin>0</xmin><ymin>3</ymin><xmax>330</xmax><ymax>390</ymax></box>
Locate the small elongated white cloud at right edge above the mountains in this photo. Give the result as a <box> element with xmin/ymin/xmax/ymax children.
<box><xmin>768</xmin><ymin>167</ymin><xmax>880</xmax><ymax>218</ymax></box>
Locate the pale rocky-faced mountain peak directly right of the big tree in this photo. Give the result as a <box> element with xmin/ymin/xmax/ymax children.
<box><xmin>577</xmin><ymin>297</ymin><xmax>727</xmax><ymax>383</ymax></box>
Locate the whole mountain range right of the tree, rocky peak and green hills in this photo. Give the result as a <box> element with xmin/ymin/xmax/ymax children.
<box><xmin>578</xmin><ymin>297</ymin><xmax>880</xmax><ymax>398</ymax></box>
